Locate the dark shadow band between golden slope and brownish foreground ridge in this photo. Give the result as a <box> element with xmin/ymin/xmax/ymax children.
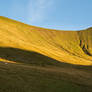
<box><xmin>0</xmin><ymin>47</ymin><xmax>91</xmax><ymax>68</ymax></box>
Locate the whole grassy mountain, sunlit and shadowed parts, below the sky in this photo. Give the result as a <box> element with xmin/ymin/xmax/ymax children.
<box><xmin>0</xmin><ymin>17</ymin><xmax>92</xmax><ymax>92</ymax></box>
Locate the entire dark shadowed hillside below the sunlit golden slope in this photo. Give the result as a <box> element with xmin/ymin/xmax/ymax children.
<box><xmin>0</xmin><ymin>47</ymin><xmax>92</xmax><ymax>92</ymax></box>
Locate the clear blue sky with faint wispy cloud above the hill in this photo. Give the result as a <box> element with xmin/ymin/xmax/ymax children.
<box><xmin>0</xmin><ymin>0</ymin><xmax>92</xmax><ymax>30</ymax></box>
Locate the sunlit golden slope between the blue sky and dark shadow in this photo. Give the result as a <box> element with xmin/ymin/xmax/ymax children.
<box><xmin>0</xmin><ymin>17</ymin><xmax>92</xmax><ymax>65</ymax></box>
